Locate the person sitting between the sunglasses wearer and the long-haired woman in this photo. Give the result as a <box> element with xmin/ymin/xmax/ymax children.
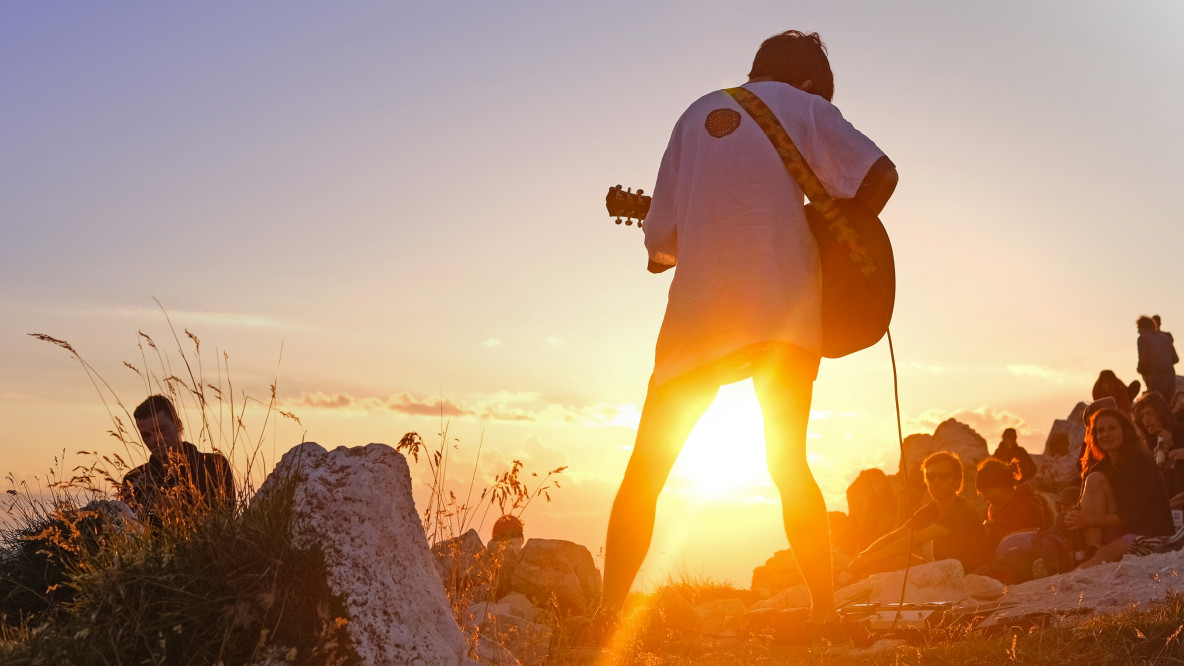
<box><xmin>974</xmin><ymin>457</ymin><xmax>1053</xmax><ymax>551</ymax></box>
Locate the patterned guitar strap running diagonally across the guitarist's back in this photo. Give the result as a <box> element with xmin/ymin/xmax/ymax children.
<box><xmin>723</xmin><ymin>88</ymin><xmax>876</xmax><ymax>277</ymax></box>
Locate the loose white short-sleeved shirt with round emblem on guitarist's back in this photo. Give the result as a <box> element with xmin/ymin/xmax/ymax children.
<box><xmin>643</xmin><ymin>81</ymin><xmax>883</xmax><ymax>385</ymax></box>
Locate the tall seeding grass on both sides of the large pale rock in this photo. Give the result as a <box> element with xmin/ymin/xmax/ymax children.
<box><xmin>0</xmin><ymin>309</ymin><xmax>565</xmax><ymax>665</ymax></box>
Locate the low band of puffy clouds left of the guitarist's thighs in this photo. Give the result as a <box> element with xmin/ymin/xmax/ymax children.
<box><xmin>283</xmin><ymin>391</ymin><xmax>639</xmax><ymax>429</ymax></box>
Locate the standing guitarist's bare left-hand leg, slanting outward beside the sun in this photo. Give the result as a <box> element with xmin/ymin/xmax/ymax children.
<box><xmin>600</xmin><ymin>369</ymin><xmax>719</xmax><ymax>613</ymax></box>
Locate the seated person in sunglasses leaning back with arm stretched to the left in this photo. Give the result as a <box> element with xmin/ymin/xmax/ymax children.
<box><xmin>848</xmin><ymin>452</ymin><xmax>992</xmax><ymax>578</ymax></box>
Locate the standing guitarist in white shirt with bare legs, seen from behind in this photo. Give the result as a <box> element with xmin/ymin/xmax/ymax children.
<box><xmin>601</xmin><ymin>31</ymin><xmax>897</xmax><ymax>626</ymax></box>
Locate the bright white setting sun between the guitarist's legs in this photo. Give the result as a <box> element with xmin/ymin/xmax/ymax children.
<box><xmin>670</xmin><ymin>379</ymin><xmax>773</xmax><ymax>499</ymax></box>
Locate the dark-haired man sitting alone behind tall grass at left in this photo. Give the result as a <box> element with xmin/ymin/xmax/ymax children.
<box><xmin>120</xmin><ymin>396</ymin><xmax>234</xmax><ymax>524</ymax></box>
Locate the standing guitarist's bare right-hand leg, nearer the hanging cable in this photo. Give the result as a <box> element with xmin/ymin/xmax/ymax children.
<box><xmin>753</xmin><ymin>352</ymin><xmax>835</xmax><ymax>622</ymax></box>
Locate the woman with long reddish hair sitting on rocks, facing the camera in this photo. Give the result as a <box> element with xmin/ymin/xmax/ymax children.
<box><xmin>1064</xmin><ymin>408</ymin><xmax>1173</xmax><ymax>566</ymax></box>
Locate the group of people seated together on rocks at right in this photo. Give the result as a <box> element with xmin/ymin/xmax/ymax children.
<box><xmin>838</xmin><ymin>392</ymin><xmax>1184</xmax><ymax>582</ymax></box>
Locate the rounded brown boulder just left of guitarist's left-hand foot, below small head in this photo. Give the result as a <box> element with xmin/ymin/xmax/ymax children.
<box><xmin>510</xmin><ymin>539</ymin><xmax>600</xmax><ymax>616</ymax></box>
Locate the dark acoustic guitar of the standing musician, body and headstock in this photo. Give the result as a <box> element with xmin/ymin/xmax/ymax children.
<box><xmin>604</xmin><ymin>185</ymin><xmax>896</xmax><ymax>358</ymax></box>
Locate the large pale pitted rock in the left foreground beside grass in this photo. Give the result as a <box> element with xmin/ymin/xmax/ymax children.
<box><xmin>256</xmin><ymin>442</ymin><xmax>471</xmax><ymax>666</ymax></box>
